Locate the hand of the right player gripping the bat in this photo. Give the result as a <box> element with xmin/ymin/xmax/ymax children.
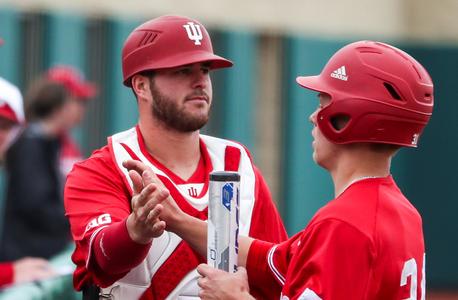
<box><xmin>197</xmin><ymin>264</ymin><xmax>254</xmax><ymax>300</ymax></box>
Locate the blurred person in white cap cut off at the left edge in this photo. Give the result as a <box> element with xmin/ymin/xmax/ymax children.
<box><xmin>0</xmin><ymin>74</ymin><xmax>55</xmax><ymax>288</ymax></box>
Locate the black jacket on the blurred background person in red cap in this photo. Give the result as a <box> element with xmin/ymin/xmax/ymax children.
<box><xmin>0</xmin><ymin>124</ymin><xmax>70</xmax><ymax>261</ymax></box>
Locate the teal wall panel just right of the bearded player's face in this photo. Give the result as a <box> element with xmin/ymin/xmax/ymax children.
<box><xmin>204</xmin><ymin>31</ymin><xmax>257</xmax><ymax>151</ymax></box>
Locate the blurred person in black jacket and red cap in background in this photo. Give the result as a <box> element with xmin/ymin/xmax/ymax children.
<box><xmin>0</xmin><ymin>66</ymin><xmax>95</xmax><ymax>261</ymax></box>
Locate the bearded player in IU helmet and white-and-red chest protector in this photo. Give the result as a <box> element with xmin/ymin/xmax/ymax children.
<box><xmin>65</xmin><ymin>16</ymin><xmax>287</xmax><ymax>299</ymax></box>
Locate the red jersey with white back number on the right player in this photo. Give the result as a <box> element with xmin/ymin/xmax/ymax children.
<box><xmin>247</xmin><ymin>176</ymin><xmax>425</xmax><ymax>300</ymax></box>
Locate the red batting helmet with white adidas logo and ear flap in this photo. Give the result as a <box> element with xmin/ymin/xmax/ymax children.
<box><xmin>296</xmin><ymin>41</ymin><xmax>434</xmax><ymax>147</ymax></box>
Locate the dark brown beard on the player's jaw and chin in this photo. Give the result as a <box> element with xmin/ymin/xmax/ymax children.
<box><xmin>150</xmin><ymin>82</ymin><xmax>210</xmax><ymax>132</ymax></box>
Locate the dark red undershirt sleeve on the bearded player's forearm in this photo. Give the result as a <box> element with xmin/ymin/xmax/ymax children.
<box><xmin>89</xmin><ymin>218</ymin><xmax>151</xmax><ymax>274</ymax></box>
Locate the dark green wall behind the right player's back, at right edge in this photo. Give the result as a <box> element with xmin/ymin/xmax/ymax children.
<box><xmin>393</xmin><ymin>44</ymin><xmax>458</xmax><ymax>289</ymax></box>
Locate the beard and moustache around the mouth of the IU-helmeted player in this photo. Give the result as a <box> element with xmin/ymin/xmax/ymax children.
<box><xmin>150</xmin><ymin>80</ymin><xmax>211</xmax><ymax>132</ymax></box>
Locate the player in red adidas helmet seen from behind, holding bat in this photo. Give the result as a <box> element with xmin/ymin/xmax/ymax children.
<box><xmin>129</xmin><ymin>41</ymin><xmax>433</xmax><ymax>300</ymax></box>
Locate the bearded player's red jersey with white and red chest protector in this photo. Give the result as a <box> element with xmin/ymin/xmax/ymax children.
<box><xmin>65</xmin><ymin>128</ymin><xmax>287</xmax><ymax>299</ymax></box>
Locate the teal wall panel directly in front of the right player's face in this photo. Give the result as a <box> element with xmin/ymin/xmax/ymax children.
<box><xmin>281</xmin><ymin>37</ymin><xmax>342</xmax><ymax>235</ymax></box>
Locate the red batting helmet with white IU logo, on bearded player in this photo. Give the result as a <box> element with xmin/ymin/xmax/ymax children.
<box><xmin>122</xmin><ymin>16</ymin><xmax>232</xmax><ymax>86</ymax></box>
